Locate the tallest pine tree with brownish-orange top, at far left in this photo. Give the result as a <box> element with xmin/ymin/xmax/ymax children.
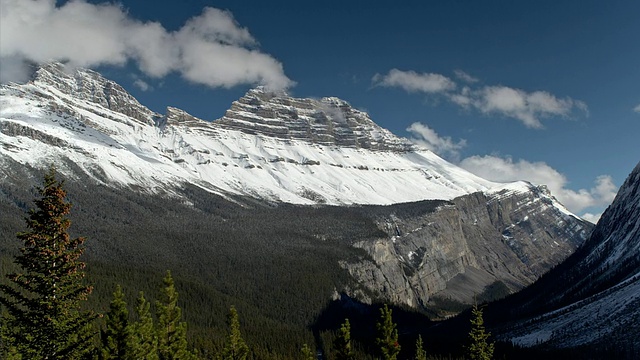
<box><xmin>0</xmin><ymin>168</ymin><xmax>96</xmax><ymax>359</ymax></box>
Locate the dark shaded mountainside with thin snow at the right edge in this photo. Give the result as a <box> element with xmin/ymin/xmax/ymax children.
<box><xmin>502</xmin><ymin>163</ymin><xmax>640</xmax><ymax>358</ymax></box>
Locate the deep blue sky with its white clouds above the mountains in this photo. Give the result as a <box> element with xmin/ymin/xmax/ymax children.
<box><xmin>0</xmin><ymin>0</ymin><xmax>640</xmax><ymax>220</ymax></box>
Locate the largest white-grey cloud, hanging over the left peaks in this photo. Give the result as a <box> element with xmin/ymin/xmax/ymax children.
<box><xmin>0</xmin><ymin>0</ymin><xmax>294</xmax><ymax>89</ymax></box>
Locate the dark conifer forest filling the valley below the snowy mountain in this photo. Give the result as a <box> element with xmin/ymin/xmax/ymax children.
<box><xmin>0</xmin><ymin>169</ymin><xmax>632</xmax><ymax>359</ymax></box>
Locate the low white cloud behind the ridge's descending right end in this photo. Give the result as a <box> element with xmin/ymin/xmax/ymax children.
<box><xmin>459</xmin><ymin>155</ymin><xmax>618</xmax><ymax>217</ymax></box>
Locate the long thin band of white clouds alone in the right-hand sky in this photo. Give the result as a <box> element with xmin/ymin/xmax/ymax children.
<box><xmin>372</xmin><ymin>69</ymin><xmax>589</xmax><ymax>129</ymax></box>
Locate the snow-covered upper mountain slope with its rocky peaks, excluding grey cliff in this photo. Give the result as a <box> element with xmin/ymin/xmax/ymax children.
<box><xmin>0</xmin><ymin>63</ymin><xmax>508</xmax><ymax>204</ymax></box>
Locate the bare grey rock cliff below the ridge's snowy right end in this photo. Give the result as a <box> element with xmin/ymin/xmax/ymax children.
<box><xmin>344</xmin><ymin>184</ymin><xmax>591</xmax><ymax>307</ymax></box>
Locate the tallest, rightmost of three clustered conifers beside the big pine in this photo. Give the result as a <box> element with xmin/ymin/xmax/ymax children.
<box><xmin>156</xmin><ymin>271</ymin><xmax>193</xmax><ymax>360</ymax></box>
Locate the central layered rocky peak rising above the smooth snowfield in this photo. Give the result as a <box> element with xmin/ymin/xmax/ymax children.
<box><xmin>216</xmin><ymin>87</ymin><xmax>414</xmax><ymax>151</ymax></box>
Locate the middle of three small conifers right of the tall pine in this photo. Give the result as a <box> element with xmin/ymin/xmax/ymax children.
<box><xmin>129</xmin><ymin>291</ymin><xmax>158</xmax><ymax>360</ymax></box>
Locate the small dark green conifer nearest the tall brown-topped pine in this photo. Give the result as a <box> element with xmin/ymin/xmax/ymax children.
<box><xmin>101</xmin><ymin>285</ymin><xmax>135</xmax><ymax>360</ymax></box>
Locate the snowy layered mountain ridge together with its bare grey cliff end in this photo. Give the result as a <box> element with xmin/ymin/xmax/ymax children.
<box><xmin>0</xmin><ymin>63</ymin><xmax>591</xmax><ymax>314</ymax></box>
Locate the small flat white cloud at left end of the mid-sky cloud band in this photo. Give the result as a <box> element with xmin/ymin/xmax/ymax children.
<box><xmin>372</xmin><ymin>69</ymin><xmax>456</xmax><ymax>93</ymax></box>
